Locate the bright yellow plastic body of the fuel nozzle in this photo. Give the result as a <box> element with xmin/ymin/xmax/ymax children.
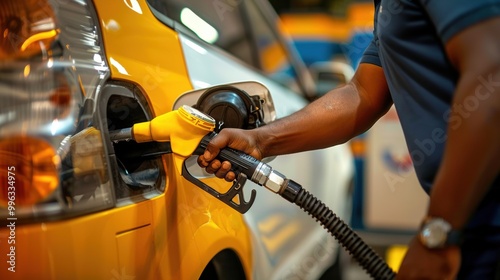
<box><xmin>132</xmin><ymin>105</ymin><xmax>215</xmax><ymax>157</ymax></box>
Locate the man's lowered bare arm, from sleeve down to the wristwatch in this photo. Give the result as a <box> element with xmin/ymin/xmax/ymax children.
<box><xmin>428</xmin><ymin>15</ymin><xmax>500</xmax><ymax>228</ymax></box>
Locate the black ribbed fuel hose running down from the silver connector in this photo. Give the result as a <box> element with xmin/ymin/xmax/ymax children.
<box><xmin>280</xmin><ymin>180</ymin><xmax>396</xmax><ymax>280</ymax></box>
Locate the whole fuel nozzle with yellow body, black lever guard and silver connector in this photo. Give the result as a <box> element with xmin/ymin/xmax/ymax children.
<box><xmin>109</xmin><ymin>105</ymin><xmax>293</xmax><ymax>210</ymax></box>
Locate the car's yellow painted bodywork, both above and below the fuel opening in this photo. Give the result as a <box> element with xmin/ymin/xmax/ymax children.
<box><xmin>0</xmin><ymin>1</ymin><xmax>252</xmax><ymax>279</ymax></box>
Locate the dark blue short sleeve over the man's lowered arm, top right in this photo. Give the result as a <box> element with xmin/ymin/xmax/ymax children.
<box><xmin>420</xmin><ymin>0</ymin><xmax>500</xmax><ymax>43</ymax></box>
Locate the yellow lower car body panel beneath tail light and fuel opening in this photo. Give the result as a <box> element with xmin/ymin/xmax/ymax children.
<box><xmin>0</xmin><ymin>172</ymin><xmax>252</xmax><ymax>279</ymax></box>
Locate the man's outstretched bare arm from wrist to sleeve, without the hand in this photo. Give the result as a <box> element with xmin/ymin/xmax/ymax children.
<box><xmin>261</xmin><ymin>65</ymin><xmax>392</xmax><ymax>156</ymax></box>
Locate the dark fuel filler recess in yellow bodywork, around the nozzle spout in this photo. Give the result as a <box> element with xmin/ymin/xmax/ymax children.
<box><xmin>99</xmin><ymin>83</ymin><xmax>168</xmax><ymax>203</ymax></box>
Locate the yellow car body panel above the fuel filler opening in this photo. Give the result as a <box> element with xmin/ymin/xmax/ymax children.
<box><xmin>95</xmin><ymin>1</ymin><xmax>192</xmax><ymax>115</ymax></box>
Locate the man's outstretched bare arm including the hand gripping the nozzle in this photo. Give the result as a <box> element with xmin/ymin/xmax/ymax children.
<box><xmin>198</xmin><ymin>63</ymin><xmax>392</xmax><ymax>181</ymax></box>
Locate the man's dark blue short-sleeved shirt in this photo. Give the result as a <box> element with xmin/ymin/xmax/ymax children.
<box><xmin>361</xmin><ymin>0</ymin><xmax>500</xmax><ymax>227</ymax></box>
